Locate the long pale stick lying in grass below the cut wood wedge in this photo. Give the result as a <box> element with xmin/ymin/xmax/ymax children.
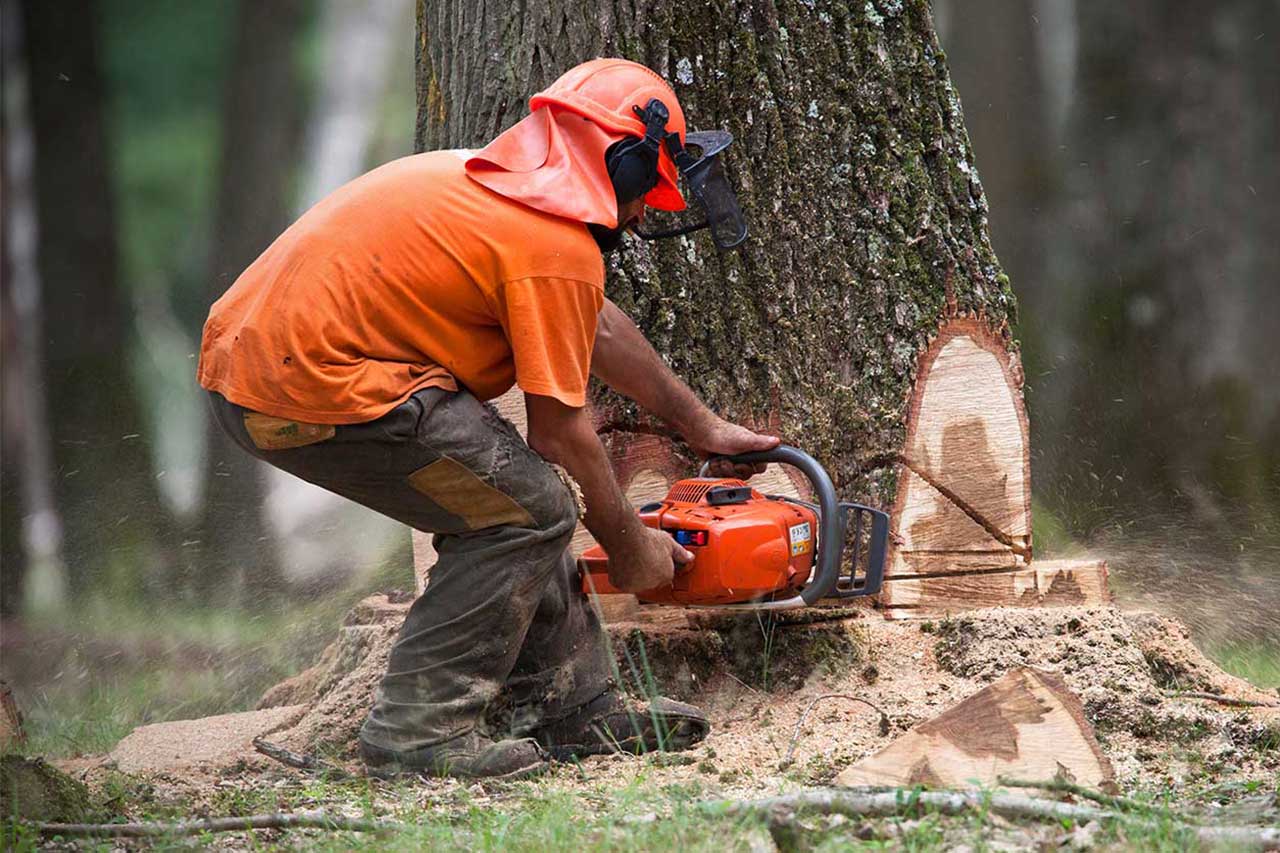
<box><xmin>704</xmin><ymin>789</ymin><xmax>1280</xmax><ymax>849</ymax></box>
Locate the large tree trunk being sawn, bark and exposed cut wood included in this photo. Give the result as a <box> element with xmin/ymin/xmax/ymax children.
<box><xmin>417</xmin><ymin>0</ymin><xmax>1111</xmax><ymax>612</ymax></box>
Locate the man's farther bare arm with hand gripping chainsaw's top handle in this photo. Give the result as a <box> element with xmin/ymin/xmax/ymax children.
<box><xmin>591</xmin><ymin>300</ymin><xmax>778</xmax><ymax>478</ymax></box>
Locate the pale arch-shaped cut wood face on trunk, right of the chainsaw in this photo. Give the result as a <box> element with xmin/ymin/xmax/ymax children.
<box><xmin>881</xmin><ymin>318</ymin><xmax>1032</xmax><ymax>613</ymax></box>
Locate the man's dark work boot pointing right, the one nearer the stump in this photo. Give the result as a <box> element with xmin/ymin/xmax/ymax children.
<box><xmin>532</xmin><ymin>690</ymin><xmax>712</xmax><ymax>761</ymax></box>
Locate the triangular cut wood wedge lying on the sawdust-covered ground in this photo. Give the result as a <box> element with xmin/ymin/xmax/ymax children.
<box><xmin>836</xmin><ymin>667</ymin><xmax>1115</xmax><ymax>788</ymax></box>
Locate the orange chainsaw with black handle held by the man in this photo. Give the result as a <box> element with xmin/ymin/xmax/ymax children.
<box><xmin>580</xmin><ymin>444</ymin><xmax>888</xmax><ymax>610</ymax></box>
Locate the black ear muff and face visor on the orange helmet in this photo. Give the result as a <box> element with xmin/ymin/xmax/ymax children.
<box><xmin>604</xmin><ymin>97</ymin><xmax>746</xmax><ymax>250</ymax></box>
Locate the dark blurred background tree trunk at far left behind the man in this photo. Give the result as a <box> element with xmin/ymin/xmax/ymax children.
<box><xmin>21</xmin><ymin>1</ymin><xmax>173</xmax><ymax>594</ymax></box>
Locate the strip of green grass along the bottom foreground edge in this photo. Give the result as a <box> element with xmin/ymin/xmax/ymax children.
<box><xmin>10</xmin><ymin>760</ymin><xmax>1276</xmax><ymax>853</ymax></box>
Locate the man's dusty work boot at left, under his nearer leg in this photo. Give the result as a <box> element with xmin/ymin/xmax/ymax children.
<box><xmin>360</xmin><ymin>731</ymin><xmax>550</xmax><ymax>779</ymax></box>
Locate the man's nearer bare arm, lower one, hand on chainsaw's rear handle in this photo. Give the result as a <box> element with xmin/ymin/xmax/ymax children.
<box><xmin>525</xmin><ymin>394</ymin><xmax>692</xmax><ymax>592</ymax></box>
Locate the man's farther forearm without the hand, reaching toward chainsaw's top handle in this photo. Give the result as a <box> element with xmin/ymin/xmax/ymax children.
<box><xmin>591</xmin><ymin>300</ymin><xmax>714</xmax><ymax>438</ymax></box>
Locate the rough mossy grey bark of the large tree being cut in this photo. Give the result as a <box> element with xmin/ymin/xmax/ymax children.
<box><xmin>416</xmin><ymin>0</ymin><xmax>1015</xmax><ymax>506</ymax></box>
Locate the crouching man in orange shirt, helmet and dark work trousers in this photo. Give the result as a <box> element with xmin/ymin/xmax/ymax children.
<box><xmin>198</xmin><ymin>59</ymin><xmax>777</xmax><ymax>777</ymax></box>
